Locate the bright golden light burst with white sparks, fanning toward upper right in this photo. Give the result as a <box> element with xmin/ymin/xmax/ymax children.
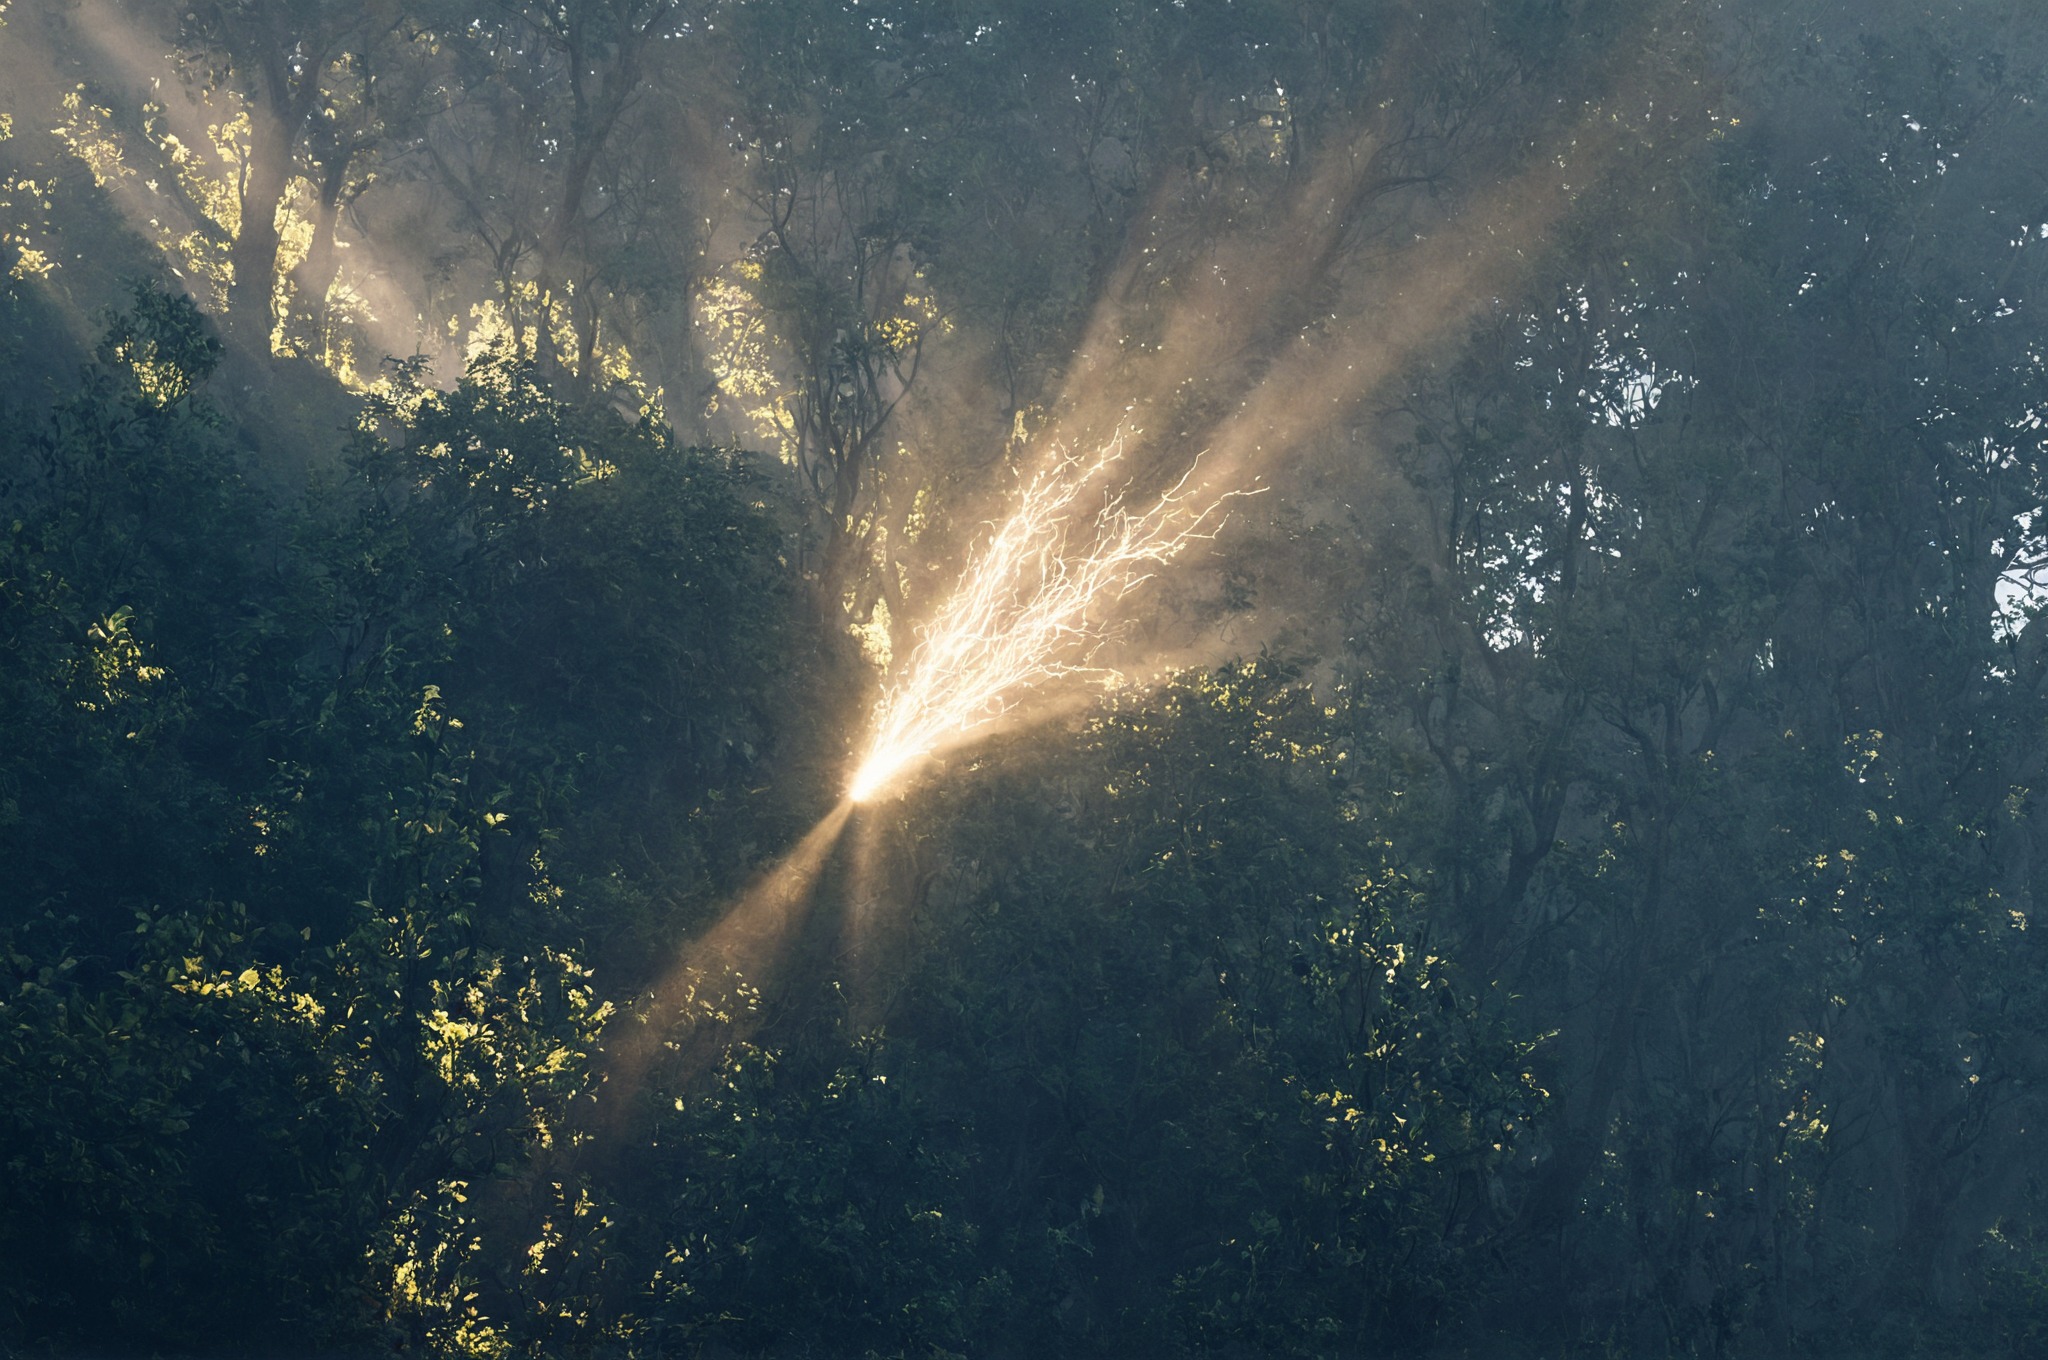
<box><xmin>848</xmin><ymin>69</ymin><xmax>1638</xmax><ymax>803</ymax></box>
